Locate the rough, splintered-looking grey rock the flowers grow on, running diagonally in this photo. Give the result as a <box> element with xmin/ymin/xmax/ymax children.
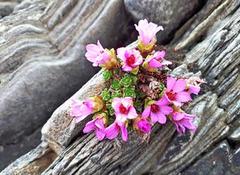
<box><xmin>2</xmin><ymin>0</ymin><xmax>240</xmax><ymax>175</ymax></box>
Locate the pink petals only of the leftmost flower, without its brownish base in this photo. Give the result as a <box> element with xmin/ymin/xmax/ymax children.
<box><xmin>70</xmin><ymin>99</ymin><xmax>94</xmax><ymax>123</ymax></box>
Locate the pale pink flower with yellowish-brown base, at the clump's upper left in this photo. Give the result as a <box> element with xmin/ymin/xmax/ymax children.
<box><xmin>85</xmin><ymin>41</ymin><xmax>117</xmax><ymax>69</ymax></box>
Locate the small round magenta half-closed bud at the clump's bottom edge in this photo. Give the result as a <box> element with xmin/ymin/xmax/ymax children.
<box><xmin>133</xmin><ymin>117</ymin><xmax>152</xmax><ymax>134</ymax></box>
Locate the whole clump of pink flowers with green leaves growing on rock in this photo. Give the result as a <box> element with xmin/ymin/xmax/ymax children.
<box><xmin>70</xmin><ymin>19</ymin><xmax>203</xmax><ymax>141</ymax></box>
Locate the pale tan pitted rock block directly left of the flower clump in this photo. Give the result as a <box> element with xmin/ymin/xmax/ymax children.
<box><xmin>42</xmin><ymin>43</ymin><xmax>135</xmax><ymax>154</ymax></box>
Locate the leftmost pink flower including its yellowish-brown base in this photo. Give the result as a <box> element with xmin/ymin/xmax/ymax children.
<box><xmin>70</xmin><ymin>96</ymin><xmax>103</xmax><ymax>123</ymax></box>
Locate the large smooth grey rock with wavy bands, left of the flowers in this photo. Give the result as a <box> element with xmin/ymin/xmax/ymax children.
<box><xmin>0</xmin><ymin>0</ymin><xmax>130</xmax><ymax>170</ymax></box>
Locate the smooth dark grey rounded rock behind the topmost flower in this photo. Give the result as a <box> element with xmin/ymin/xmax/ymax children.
<box><xmin>124</xmin><ymin>0</ymin><xmax>200</xmax><ymax>42</ymax></box>
